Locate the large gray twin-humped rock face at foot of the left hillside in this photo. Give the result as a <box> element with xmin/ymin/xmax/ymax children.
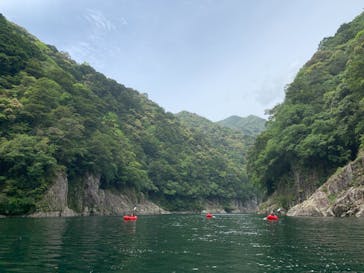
<box><xmin>30</xmin><ymin>173</ymin><xmax>167</xmax><ymax>217</ymax></box>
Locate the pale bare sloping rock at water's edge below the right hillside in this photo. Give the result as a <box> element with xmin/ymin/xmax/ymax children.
<box><xmin>287</xmin><ymin>152</ymin><xmax>364</xmax><ymax>217</ymax></box>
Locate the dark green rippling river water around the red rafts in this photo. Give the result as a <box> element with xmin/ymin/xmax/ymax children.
<box><xmin>0</xmin><ymin>215</ymin><xmax>364</xmax><ymax>273</ymax></box>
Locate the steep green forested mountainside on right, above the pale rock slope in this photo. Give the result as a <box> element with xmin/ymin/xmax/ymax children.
<box><xmin>248</xmin><ymin>11</ymin><xmax>364</xmax><ymax>207</ymax></box>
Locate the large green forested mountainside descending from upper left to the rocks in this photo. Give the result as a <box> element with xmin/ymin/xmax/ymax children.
<box><xmin>0</xmin><ymin>15</ymin><xmax>258</xmax><ymax>215</ymax></box>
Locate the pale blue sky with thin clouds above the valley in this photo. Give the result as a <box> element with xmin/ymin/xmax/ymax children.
<box><xmin>0</xmin><ymin>0</ymin><xmax>364</xmax><ymax>121</ymax></box>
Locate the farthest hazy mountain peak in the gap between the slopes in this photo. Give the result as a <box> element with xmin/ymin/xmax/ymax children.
<box><xmin>217</xmin><ymin>115</ymin><xmax>266</xmax><ymax>137</ymax></box>
